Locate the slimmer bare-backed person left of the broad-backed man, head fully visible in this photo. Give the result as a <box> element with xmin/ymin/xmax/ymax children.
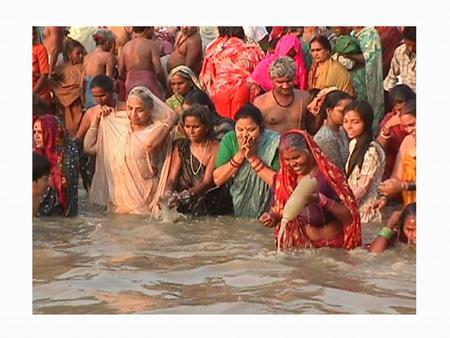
<box><xmin>83</xmin><ymin>29</ymin><xmax>116</xmax><ymax>109</ymax></box>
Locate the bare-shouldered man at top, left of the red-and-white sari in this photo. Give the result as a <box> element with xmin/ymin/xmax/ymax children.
<box><xmin>167</xmin><ymin>27</ymin><xmax>202</xmax><ymax>75</ymax></box>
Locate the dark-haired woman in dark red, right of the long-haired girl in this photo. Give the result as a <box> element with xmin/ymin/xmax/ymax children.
<box><xmin>377</xmin><ymin>84</ymin><xmax>416</xmax><ymax>180</ymax></box>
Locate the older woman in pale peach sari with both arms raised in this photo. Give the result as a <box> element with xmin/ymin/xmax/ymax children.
<box><xmin>84</xmin><ymin>86</ymin><xmax>178</xmax><ymax>216</ymax></box>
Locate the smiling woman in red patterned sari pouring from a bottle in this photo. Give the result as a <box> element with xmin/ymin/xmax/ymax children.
<box><xmin>260</xmin><ymin>129</ymin><xmax>361</xmax><ymax>250</ymax></box>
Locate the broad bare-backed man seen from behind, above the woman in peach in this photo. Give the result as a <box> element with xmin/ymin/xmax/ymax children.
<box><xmin>119</xmin><ymin>27</ymin><xmax>166</xmax><ymax>100</ymax></box>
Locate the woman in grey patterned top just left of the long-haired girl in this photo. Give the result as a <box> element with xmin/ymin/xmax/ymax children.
<box><xmin>314</xmin><ymin>90</ymin><xmax>352</xmax><ymax>170</ymax></box>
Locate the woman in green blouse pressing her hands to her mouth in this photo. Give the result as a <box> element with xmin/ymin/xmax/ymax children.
<box><xmin>213</xmin><ymin>104</ymin><xmax>280</xmax><ymax>218</ymax></box>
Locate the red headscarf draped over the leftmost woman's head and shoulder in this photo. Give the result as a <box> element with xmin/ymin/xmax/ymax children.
<box><xmin>33</xmin><ymin>114</ymin><xmax>68</xmax><ymax>210</ymax></box>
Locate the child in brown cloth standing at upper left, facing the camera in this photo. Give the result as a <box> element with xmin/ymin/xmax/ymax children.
<box><xmin>51</xmin><ymin>39</ymin><xmax>84</xmax><ymax>137</ymax></box>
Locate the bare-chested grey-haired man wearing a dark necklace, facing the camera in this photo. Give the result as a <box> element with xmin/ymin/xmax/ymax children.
<box><xmin>253</xmin><ymin>56</ymin><xmax>311</xmax><ymax>133</ymax></box>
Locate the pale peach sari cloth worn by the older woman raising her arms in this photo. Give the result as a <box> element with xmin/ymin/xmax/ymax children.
<box><xmin>85</xmin><ymin>87</ymin><xmax>173</xmax><ymax>217</ymax></box>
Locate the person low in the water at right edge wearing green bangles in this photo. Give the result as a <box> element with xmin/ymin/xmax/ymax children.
<box><xmin>366</xmin><ymin>203</ymin><xmax>416</xmax><ymax>253</ymax></box>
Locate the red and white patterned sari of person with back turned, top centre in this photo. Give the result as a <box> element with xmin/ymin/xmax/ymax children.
<box><xmin>200</xmin><ymin>36</ymin><xmax>264</xmax><ymax>119</ymax></box>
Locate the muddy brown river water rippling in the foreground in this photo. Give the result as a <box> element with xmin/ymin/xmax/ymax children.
<box><xmin>33</xmin><ymin>191</ymin><xmax>416</xmax><ymax>314</ymax></box>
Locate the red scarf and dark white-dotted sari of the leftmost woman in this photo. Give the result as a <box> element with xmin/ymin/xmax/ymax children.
<box><xmin>33</xmin><ymin>115</ymin><xmax>79</xmax><ymax>216</ymax></box>
